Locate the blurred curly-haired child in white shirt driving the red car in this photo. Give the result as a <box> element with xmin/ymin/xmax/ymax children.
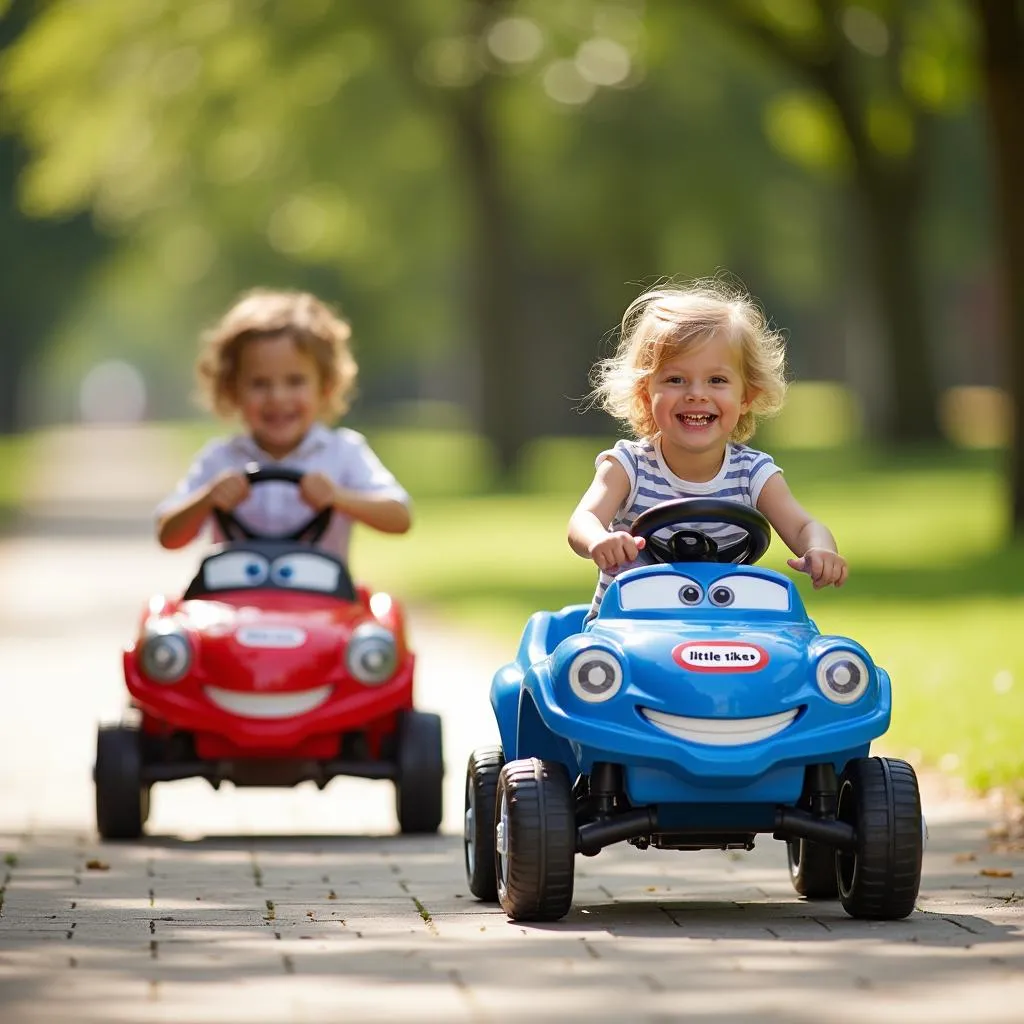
<box><xmin>157</xmin><ymin>289</ymin><xmax>411</xmax><ymax>561</ymax></box>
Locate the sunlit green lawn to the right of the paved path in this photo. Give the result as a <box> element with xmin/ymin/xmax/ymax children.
<box><xmin>353</xmin><ymin>441</ymin><xmax>1024</xmax><ymax>787</ymax></box>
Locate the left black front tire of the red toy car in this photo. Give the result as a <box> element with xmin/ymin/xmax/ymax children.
<box><xmin>92</xmin><ymin>725</ymin><xmax>150</xmax><ymax>839</ymax></box>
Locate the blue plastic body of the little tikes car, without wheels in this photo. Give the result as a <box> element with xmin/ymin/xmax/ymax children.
<box><xmin>490</xmin><ymin>563</ymin><xmax>892</xmax><ymax>828</ymax></box>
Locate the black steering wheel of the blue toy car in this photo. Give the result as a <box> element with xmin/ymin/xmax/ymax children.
<box><xmin>630</xmin><ymin>498</ymin><xmax>771</xmax><ymax>565</ymax></box>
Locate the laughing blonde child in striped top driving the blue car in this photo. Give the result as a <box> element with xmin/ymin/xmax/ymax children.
<box><xmin>568</xmin><ymin>282</ymin><xmax>847</xmax><ymax>617</ymax></box>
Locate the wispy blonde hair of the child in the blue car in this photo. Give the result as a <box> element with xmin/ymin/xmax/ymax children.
<box><xmin>591</xmin><ymin>280</ymin><xmax>786</xmax><ymax>441</ymax></box>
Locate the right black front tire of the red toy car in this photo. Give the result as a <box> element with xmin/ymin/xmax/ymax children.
<box><xmin>394</xmin><ymin>711</ymin><xmax>444</xmax><ymax>834</ymax></box>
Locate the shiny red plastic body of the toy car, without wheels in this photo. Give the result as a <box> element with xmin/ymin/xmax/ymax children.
<box><xmin>124</xmin><ymin>588</ymin><xmax>415</xmax><ymax>761</ymax></box>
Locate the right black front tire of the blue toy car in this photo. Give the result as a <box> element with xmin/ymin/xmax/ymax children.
<box><xmin>836</xmin><ymin>758</ymin><xmax>924</xmax><ymax>921</ymax></box>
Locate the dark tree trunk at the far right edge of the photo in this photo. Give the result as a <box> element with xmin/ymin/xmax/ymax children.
<box><xmin>978</xmin><ymin>0</ymin><xmax>1024</xmax><ymax>539</ymax></box>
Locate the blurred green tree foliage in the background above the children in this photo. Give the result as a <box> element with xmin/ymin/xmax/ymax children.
<box><xmin>0</xmin><ymin>0</ymin><xmax>997</xmax><ymax>454</ymax></box>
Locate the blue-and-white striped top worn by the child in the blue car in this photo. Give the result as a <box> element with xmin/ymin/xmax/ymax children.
<box><xmin>589</xmin><ymin>437</ymin><xmax>782</xmax><ymax>617</ymax></box>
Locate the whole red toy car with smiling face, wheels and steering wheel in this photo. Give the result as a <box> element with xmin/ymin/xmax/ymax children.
<box><xmin>93</xmin><ymin>467</ymin><xmax>443</xmax><ymax>839</ymax></box>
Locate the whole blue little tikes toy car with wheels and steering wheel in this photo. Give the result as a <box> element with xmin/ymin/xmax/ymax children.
<box><xmin>464</xmin><ymin>499</ymin><xmax>924</xmax><ymax>921</ymax></box>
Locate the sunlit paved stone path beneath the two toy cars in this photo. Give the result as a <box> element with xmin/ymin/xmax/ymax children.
<box><xmin>0</xmin><ymin>423</ymin><xmax>1024</xmax><ymax>1024</ymax></box>
